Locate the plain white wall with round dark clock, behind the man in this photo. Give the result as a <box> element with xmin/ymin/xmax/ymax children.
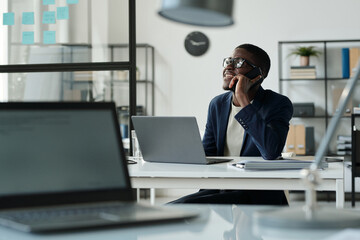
<box><xmin>136</xmin><ymin>0</ymin><xmax>360</xmax><ymax>131</ymax></box>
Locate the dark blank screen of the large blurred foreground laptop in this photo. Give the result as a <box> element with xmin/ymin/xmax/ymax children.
<box><xmin>0</xmin><ymin>103</ymin><xmax>129</xmax><ymax>205</ymax></box>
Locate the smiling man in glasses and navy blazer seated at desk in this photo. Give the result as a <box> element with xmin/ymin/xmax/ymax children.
<box><xmin>172</xmin><ymin>44</ymin><xmax>293</xmax><ymax>205</ymax></box>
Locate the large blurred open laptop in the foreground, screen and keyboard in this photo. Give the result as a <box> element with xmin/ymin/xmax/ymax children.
<box><xmin>0</xmin><ymin>102</ymin><xmax>196</xmax><ymax>232</ymax></box>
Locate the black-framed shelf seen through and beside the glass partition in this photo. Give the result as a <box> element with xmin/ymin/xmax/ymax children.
<box><xmin>61</xmin><ymin>43</ymin><xmax>155</xmax><ymax>115</ymax></box>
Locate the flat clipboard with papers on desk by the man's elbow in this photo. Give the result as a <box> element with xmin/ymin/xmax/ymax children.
<box><xmin>232</xmin><ymin>159</ymin><xmax>327</xmax><ymax>170</ymax></box>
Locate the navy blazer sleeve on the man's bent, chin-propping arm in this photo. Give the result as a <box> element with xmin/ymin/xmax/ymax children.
<box><xmin>235</xmin><ymin>96</ymin><xmax>293</xmax><ymax>159</ymax></box>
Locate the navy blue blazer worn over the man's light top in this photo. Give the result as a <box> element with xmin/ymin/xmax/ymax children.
<box><xmin>203</xmin><ymin>86</ymin><xmax>293</xmax><ymax>159</ymax></box>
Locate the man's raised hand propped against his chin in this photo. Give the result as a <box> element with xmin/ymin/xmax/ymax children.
<box><xmin>229</xmin><ymin>74</ymin><xmax>261</xmax><ymax>107</ymax></box>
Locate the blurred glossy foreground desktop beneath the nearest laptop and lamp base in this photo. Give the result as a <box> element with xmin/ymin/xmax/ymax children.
<box><xmin>0</xmin><ymin>205</ymin><xmax>354</xmax><ymax>240</ymax></box>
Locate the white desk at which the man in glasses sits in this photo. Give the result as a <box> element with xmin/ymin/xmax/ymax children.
<box><xmin>129</xmin><ymin>157</ymin><xmax>345</xmax><ymax>208</ymax></box>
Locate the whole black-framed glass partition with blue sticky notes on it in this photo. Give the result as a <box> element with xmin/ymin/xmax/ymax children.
<box><xmin>0</xmin><ymin>0</ymin><xmax>136</xmax><ymax>150</ymax></box>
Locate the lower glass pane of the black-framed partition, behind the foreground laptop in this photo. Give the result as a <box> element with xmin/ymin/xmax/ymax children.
<box><xmin>0</xmin><ymin>70</ymin><xmax>148</xmax><ymax>144</ymax></box>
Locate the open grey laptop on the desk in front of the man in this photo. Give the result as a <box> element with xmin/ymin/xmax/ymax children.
<box><xmin>132</xmin><ymin>116</ymin><xmax>232</xmax><ymax>164</ymax></box>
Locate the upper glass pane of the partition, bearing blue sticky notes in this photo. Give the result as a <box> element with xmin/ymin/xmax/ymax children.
<box><xmin>0</xmin><ymin>0</ymin><xmax>129</xmax><ymax>64</ymax></box>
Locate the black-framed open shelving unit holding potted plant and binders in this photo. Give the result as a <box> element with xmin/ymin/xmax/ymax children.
<box><xmin>278</xmin><ymin>39</ymin><xmax>360</xmax><ymax>155</ymax></box>
